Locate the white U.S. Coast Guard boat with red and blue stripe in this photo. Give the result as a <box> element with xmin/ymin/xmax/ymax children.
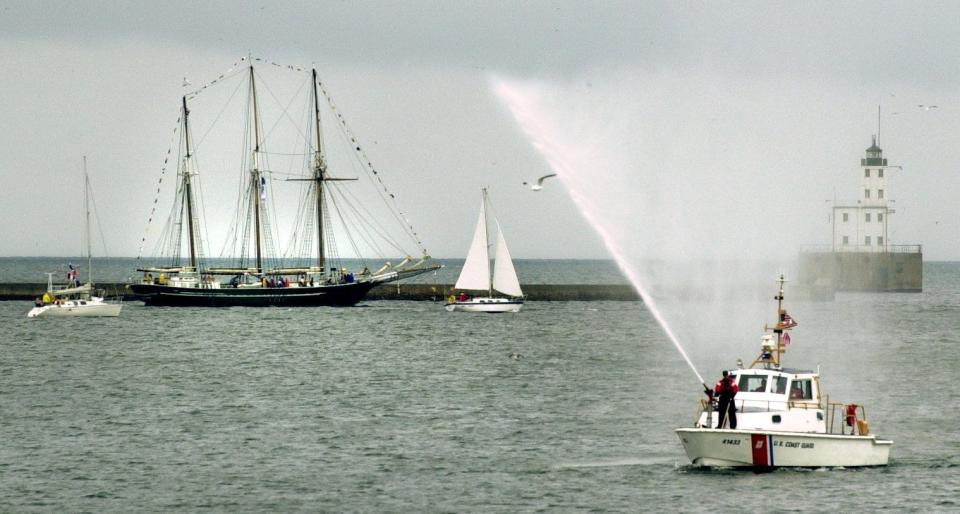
<box><xmin>676</xmin><ymin>276</ymin><xmax>893</xmax><ymax>468</ymax></box>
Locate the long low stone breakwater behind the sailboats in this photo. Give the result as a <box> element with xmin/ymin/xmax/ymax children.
<box><xmin>0</xmin><ymin>283</ymin><xmax>640</xmax><ymax>302</ymax></box>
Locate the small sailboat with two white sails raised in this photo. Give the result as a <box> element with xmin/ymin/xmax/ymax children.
<box><xmin>446</xmin><ymin>188</ymin><xmax>523</xmax><ymax>312</ymax></box>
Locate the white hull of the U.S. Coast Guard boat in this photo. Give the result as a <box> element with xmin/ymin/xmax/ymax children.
<box><xmin>676</xmin><ymin>428</ymin><xmax>893</xmax><ymax>468</ymax></box>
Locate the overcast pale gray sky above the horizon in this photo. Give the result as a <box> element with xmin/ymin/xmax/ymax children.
<box><xmin>0</xmin><ymin>1</ymin><xmax>960</xmax><ymax>260</ymax></box>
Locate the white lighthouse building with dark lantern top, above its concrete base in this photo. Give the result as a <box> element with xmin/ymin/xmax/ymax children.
<box><xmin>832</xmin><ymin>136</ymin><xmax>900</xmax><ymax>252</ymax></box>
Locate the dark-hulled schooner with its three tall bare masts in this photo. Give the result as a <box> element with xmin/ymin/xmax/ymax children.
<box><xmin>129</xmin><ymin>59</ymin><xmax>440</xmax><ymax>307</ymax></box>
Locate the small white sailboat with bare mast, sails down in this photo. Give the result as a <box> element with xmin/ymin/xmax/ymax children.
<box><xmin>27</xmin><ymin>157</ymin><xmax>123</xmax><ymax>318</ymax></box>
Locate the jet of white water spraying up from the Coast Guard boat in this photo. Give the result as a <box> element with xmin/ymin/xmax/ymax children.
<box><xmin>493</xmin><ymin>79</ymin><xmax>709</xmax><ymax>391</ymax></box>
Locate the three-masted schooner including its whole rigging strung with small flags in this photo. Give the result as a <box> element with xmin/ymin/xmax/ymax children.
<box><xmin>129</xmin><ymin>58</ymin><xmax>440</xmax><ymax>306</ymax></box>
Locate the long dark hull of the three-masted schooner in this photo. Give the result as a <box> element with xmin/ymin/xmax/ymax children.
<box><xmin>129</xmin><ymin>282</ymin><xmax>377</xmax><ymax>307</ymax></box>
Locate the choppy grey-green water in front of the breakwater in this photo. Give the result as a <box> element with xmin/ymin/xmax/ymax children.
<box><xmin>0</xmin><ymin>264</ymin><xmax>960</xmax><ymax>512</ymax></box>
